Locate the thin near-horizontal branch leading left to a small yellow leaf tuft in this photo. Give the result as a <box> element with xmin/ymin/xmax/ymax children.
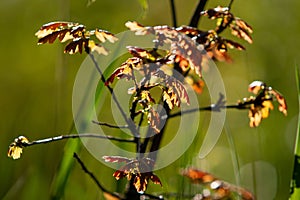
<box><xmin>23</xmin><ymin>133</ymin><xmax>134</xmax><ymax>147</ymax></box>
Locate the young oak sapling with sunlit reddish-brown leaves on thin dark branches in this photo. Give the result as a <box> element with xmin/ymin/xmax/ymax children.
<box><xmin>8</xmin><ymin>0</ymin><xmax>287</xmax><ymax>199</ymax></box>
